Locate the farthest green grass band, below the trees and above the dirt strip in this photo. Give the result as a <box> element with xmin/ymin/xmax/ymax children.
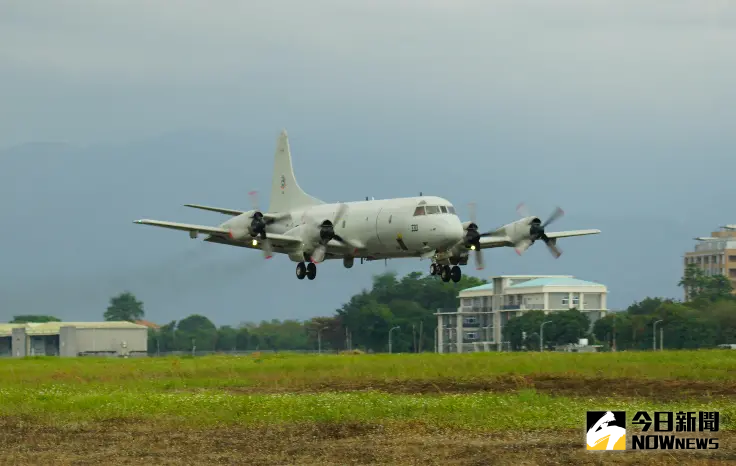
<box><xmin>0</xmin><ymin>350</ymin><xmax>736</xmax><ymax>390</ymax></box>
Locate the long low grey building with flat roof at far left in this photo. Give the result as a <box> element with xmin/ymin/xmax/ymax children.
<box><xmin>0</xmin><ymin>322</ymin><xmax>148</xmax><ymax>357</ymax></box>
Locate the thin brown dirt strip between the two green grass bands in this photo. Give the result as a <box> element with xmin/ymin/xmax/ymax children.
<box><xmin>220</xmin><ymin>375</ymin><xmax>736</xmax><ymax>401</ymax></box>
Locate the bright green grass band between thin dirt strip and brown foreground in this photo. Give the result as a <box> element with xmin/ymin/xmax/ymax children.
<box><xmin>0</xmin><ymin>386</ymin><xmax>736</xmax><ymax>431</ymax></box>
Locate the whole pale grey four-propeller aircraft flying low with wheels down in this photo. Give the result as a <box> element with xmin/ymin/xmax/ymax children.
<box><xmin>135</xmin><ymin>131</ymin><xmax>600</xmax><ymax>282</ymax></box>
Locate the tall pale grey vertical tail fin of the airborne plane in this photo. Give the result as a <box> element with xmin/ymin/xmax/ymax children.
<box><xmin>268</xmin><ymin>130</ymin><xmax>324</xmax><ymax>212</ymax></box>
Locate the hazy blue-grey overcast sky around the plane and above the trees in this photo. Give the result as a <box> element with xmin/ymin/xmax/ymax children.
<box><xmin>0</xmin><ymin>0</ymin><xmax>736</xmax><ymax>325</ymax></box>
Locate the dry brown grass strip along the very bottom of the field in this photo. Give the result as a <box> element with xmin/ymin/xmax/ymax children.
<box><xmin>0</xmin><ymin>418</ymin><xmax>736</xmax><ymax>465</ymax></box>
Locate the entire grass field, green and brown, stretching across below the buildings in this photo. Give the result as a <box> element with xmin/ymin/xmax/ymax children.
<box><xmin>0</xmin><ymin>351</ymin><xmax>736</xmax><ymax>464</ymax></box>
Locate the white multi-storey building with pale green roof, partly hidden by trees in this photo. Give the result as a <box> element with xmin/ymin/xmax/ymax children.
<box><xmin>435</xmin><ymin>275</ymin><xmax>608</xmax><ymax>353</ymax></box>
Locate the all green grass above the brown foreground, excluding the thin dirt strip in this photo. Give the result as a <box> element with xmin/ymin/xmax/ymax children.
<box><xmin>0</xmin><ymin>351</ymin><xmax>736</xmax><ymax>431</ymax></box>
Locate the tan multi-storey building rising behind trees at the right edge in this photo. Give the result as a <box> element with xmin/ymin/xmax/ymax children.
<box><xmin>683</xmin><ymin>225</ymin><xmax>736</xmax><ymax>301</ymax></box>
